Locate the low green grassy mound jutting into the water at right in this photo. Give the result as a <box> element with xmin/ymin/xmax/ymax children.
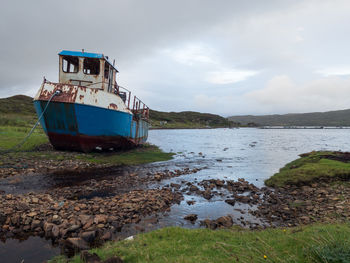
<box><xmin>265</xmin><ymin>152</ymin><xmax>350</xmax><ymax>187</ymax></box>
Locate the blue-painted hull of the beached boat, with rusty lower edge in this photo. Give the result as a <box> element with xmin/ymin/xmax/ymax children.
<box><xmin>34</xmin><ymin>100</ymin><xmax>149</xmax><ymax>152</ymax></box>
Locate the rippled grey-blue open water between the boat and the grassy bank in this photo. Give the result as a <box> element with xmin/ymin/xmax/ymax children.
<box><xmin>149</xmin><ymin>128</ymin><xmax>350</xmax><ymax>186</ymax></box>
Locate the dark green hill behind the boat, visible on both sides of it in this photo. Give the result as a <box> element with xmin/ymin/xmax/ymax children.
<box><xmin>0</xmin><ymin>95</ymin><xmax>235</xmax><ymax>128</ymax></box>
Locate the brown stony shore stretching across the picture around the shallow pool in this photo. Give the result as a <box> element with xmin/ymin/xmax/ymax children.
<box><xmin>0</xmin><ymin>145</ymin><xmax>350</xmax><ymax>262</ymax></box>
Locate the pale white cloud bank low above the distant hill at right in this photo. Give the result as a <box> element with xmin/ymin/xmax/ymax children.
<box><xmin>244</xmin><ymin>75</ymin><xmax>350</xmax><ymax>113</ymax></box>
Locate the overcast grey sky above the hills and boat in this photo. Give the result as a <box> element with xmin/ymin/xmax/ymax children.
<box><xmin>0</xmin><ymin>0</ymin><xmax>350</xmax><ymax>117</ymax></box>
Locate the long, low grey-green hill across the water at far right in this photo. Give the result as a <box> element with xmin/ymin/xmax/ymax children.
<box><xmin>228</xmin><ymin>109</ymin><xmax>350</xmax><ymax>126</ymax></box>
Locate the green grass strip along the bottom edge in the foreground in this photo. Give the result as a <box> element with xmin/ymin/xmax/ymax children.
<box><xmin>51</xmin><ymin>224</ymin><xmax>350</xmax><ymax>263</ymax></box>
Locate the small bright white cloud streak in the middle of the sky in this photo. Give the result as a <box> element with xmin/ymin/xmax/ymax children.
<box><xmin>206</xmin><ymin>69</ymin><xmax>259</xmax><ymax>84</ymax></box>
